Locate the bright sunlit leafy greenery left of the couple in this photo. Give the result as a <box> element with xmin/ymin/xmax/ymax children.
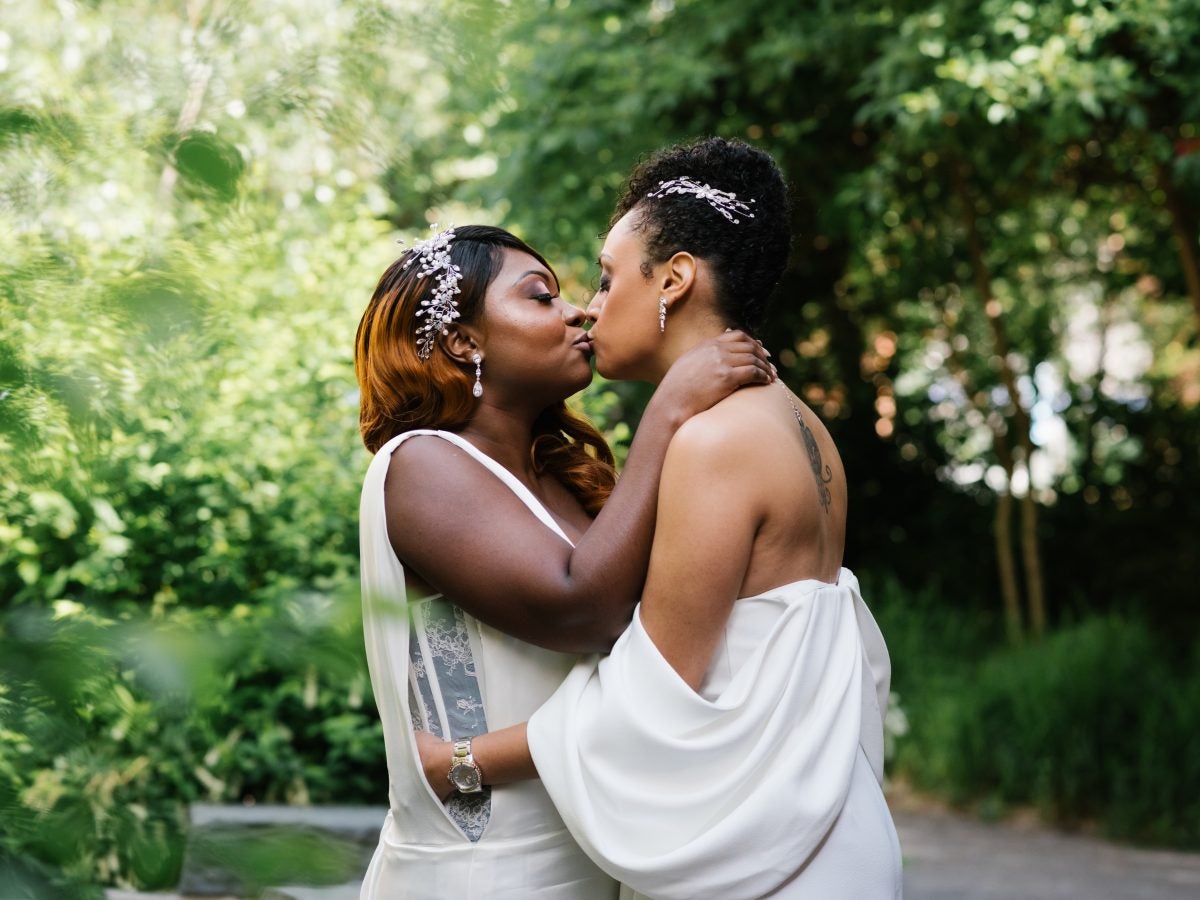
<box><xmin>0</xmin><ymin>2</ymin><xmax>439</xmax><ymax>895</ymax></box>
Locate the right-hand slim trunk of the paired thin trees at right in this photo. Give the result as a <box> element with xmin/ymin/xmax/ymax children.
<box><xmin>954</xmin><ymin>164</ymin><xmax>1046</xmax><ymax>636</ymax></box>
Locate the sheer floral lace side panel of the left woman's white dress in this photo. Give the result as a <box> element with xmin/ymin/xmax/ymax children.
<box><xmin>408</xmin><ymin>596</ymin><xmax>492</xmax><ymax>841</ymax></box>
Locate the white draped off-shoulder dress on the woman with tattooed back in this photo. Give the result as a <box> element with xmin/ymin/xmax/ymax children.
<box><xmin>529</xmin><ymin>569</ymin><xmax>902</xmax><ymax>900</ymax></box>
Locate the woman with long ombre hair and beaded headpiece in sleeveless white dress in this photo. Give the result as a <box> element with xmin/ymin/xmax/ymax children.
<box><xmin>355</xmin><ymin>226</ymin><xmax>773</xmax><ymax>900</ymax></box>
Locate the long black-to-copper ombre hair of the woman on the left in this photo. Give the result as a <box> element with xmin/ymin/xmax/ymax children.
<box><xmin>354</xmin><ymin>226</ymin><xmax>617</xmax><ymax>516</ymax></box>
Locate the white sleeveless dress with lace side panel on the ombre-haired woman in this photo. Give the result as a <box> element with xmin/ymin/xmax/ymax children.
<box><xmin>359</xmin><ymin>431</ymin><xmax>618</xmax><ymax>900</ymax></box>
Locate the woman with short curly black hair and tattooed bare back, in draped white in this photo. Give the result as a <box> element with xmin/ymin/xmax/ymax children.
<box><xmin>422</xmin><ymin>139</ymin><xmax>901</xmax><ymax>900</ymax></box>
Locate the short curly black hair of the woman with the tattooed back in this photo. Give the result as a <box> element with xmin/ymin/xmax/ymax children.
<box><xmin>610</xmin><ymin>137</ymin><xmax>792</xmax><ymax>331</ymax></box>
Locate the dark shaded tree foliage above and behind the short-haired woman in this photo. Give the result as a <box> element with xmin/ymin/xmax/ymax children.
<box><xmin>432</xmin><ymin>0</ymin><xmax>1200</xmax><ymax>628</ymax></box>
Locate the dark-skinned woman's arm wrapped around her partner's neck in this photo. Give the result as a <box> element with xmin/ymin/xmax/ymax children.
<box><xmin>386</xmin><ymin>331</ymin><xmax>773</xmax><ymax>652</ymax></box>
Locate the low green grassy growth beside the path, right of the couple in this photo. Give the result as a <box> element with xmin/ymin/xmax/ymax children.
<box><xmin>888</xmin><ymin>610</ymin><xmax>1200</xmax><ymax>847</ymax></box>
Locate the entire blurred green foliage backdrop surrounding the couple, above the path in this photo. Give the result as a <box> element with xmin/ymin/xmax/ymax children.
<box><xmin>0</xmin><ymin>0</ymin><xmax>1200</xmax><ymax>895</ymax></box>
